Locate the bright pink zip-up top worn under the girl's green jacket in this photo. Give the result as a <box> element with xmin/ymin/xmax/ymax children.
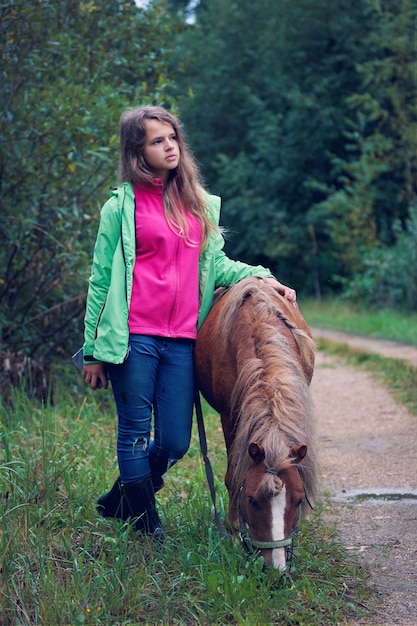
<box><xmin>129</xmin><ymin>179</ymin><xmax>201</xmax><ymax>339</ymax></box>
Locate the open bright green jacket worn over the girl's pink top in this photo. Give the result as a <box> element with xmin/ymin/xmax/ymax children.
<box><xmin>84</xmin><ymin>183</ymin><xmax>272</xmax><ymax>363</ymax></box>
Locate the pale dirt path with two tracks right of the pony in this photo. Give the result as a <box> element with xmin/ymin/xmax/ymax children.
<box><xmin>312</xmin><ymin>330</ymin><xmax>417</xmax><ymax>626</ymax></box>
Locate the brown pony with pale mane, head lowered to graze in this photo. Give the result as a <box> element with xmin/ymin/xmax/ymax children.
<box><xmin>195</xmin><ymin>278</ymin><xmax>316</xmax><ymax>570</ymax></box>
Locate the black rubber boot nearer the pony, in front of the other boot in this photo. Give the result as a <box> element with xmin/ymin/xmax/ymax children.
<box><xmin>123</xmin><ymin>478</ymin><xmax>164</xmax><ymax>541</ymax></box>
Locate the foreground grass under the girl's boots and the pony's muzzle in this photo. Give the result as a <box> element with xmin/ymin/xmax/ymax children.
<box><xmin>0</xmin><ymin>371</ymin><xmax>370</xmax><ymax>626</ymax></box>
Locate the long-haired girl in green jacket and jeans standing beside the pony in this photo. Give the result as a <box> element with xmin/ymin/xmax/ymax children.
<box><xmin>82</xmin><ymin>106</ymin><xmax>296</xmax><ymax>537</ymax></box>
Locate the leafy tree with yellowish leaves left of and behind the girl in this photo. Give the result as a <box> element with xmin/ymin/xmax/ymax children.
<box><xmin>0</xmin><ymin>0</ymin><xmax>180</xmax><ymax>356</ymax></box>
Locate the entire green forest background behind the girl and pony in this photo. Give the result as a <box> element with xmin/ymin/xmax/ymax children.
<box><xmin>0</xmin><ymin>0</ymin><xmax>417</xmax><ymax>358</ymax></box>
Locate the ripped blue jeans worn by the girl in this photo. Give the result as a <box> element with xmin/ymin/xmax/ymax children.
<box><xmin>108</xmin><ymin>335</ymin><xmax>194</xmax><ymax>485</ymax></box>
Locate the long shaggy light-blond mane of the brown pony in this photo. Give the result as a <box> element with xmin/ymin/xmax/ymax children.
<box><xmin>216</xmin><ymin>279</ymin><xmax>316</xmax><ymax>512</ymax></box>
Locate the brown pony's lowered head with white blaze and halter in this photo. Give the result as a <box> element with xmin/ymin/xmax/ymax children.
<box><xmin>238</xmin><ymin>442</ymin><xmax>307</xmax><ymax>571</ymax></box>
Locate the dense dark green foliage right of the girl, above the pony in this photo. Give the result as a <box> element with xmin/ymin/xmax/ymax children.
<box><xmin>176</xmin><ymin>0</ymin><xmax>417</xmax><ymax>305</ymax></box>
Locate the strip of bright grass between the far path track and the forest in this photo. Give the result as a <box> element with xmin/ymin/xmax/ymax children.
<box><xmin>300</xmin><ymin>298</ymin><xmax>417</xmax><ymax>346</ymax></box>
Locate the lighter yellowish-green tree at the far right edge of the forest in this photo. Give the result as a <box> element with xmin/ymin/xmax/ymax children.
<box><xmin>310</xmin><ymin>0</ymin><xmax>417</xmax><ymax>294</ymax></box>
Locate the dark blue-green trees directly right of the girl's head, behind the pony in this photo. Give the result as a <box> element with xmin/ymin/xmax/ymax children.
<box><xmin>171</xmin><ymin>0</ymin><xmax>370</xmax><ymax>289</ymax></box>
